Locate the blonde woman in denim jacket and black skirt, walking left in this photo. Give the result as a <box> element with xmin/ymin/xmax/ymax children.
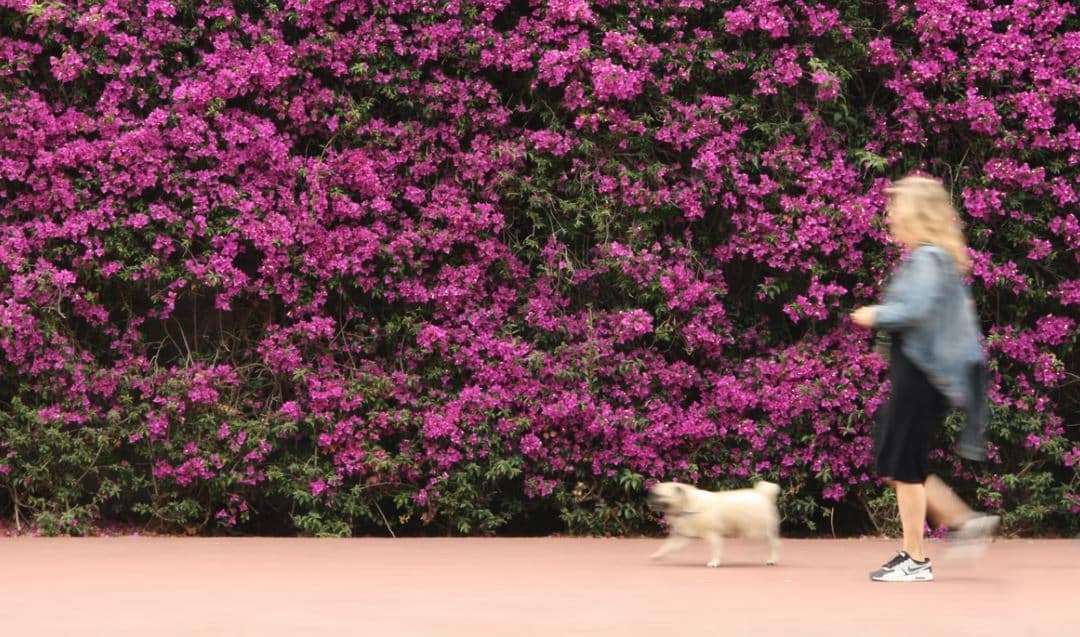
<box><xmin>851</xmin><ymin>176</ymin><xmax>1000</xmax><ymax>582</ymax></box>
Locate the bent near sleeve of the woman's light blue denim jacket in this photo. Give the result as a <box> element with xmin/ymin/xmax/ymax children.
<box><xmin>874</xmin><ymin>247</ymin><xmax>942</xmax><ymax>330</ymax></box>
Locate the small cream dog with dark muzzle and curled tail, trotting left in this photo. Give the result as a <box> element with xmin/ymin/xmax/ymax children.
<box><xmin>647</xmin><ymin>480</ymin><xmax>780</xmax><ymax>568</ymax></box>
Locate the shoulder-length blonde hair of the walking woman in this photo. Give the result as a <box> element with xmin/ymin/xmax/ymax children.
<box><xmin>885</xmin><ymin>175</ymin><xmax>971</xmax><ymax>273</ymax></box>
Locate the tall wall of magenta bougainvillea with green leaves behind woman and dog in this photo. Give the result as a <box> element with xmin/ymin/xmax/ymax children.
<box><xmin>0</xmin><ymin>0</ymin><xmax>1080</xmax><ymax>534</ymax></box>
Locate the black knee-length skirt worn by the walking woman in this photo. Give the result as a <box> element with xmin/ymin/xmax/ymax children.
<box><xmin>874</xmin><ymin>333</ymin><xmax>948</xmax><ymax>484</ymax></box>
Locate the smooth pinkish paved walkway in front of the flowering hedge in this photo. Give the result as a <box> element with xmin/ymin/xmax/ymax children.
<box><xmin>0</xmin><ymin>538</ymin><xmax>1080</xmax><ymax>637</ymax></box>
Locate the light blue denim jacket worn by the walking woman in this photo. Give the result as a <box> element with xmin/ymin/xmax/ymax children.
<box><xmin>874</xmin><ymin>244</ymin><xmax>989</xmax><ymax>460</ymax></box>
